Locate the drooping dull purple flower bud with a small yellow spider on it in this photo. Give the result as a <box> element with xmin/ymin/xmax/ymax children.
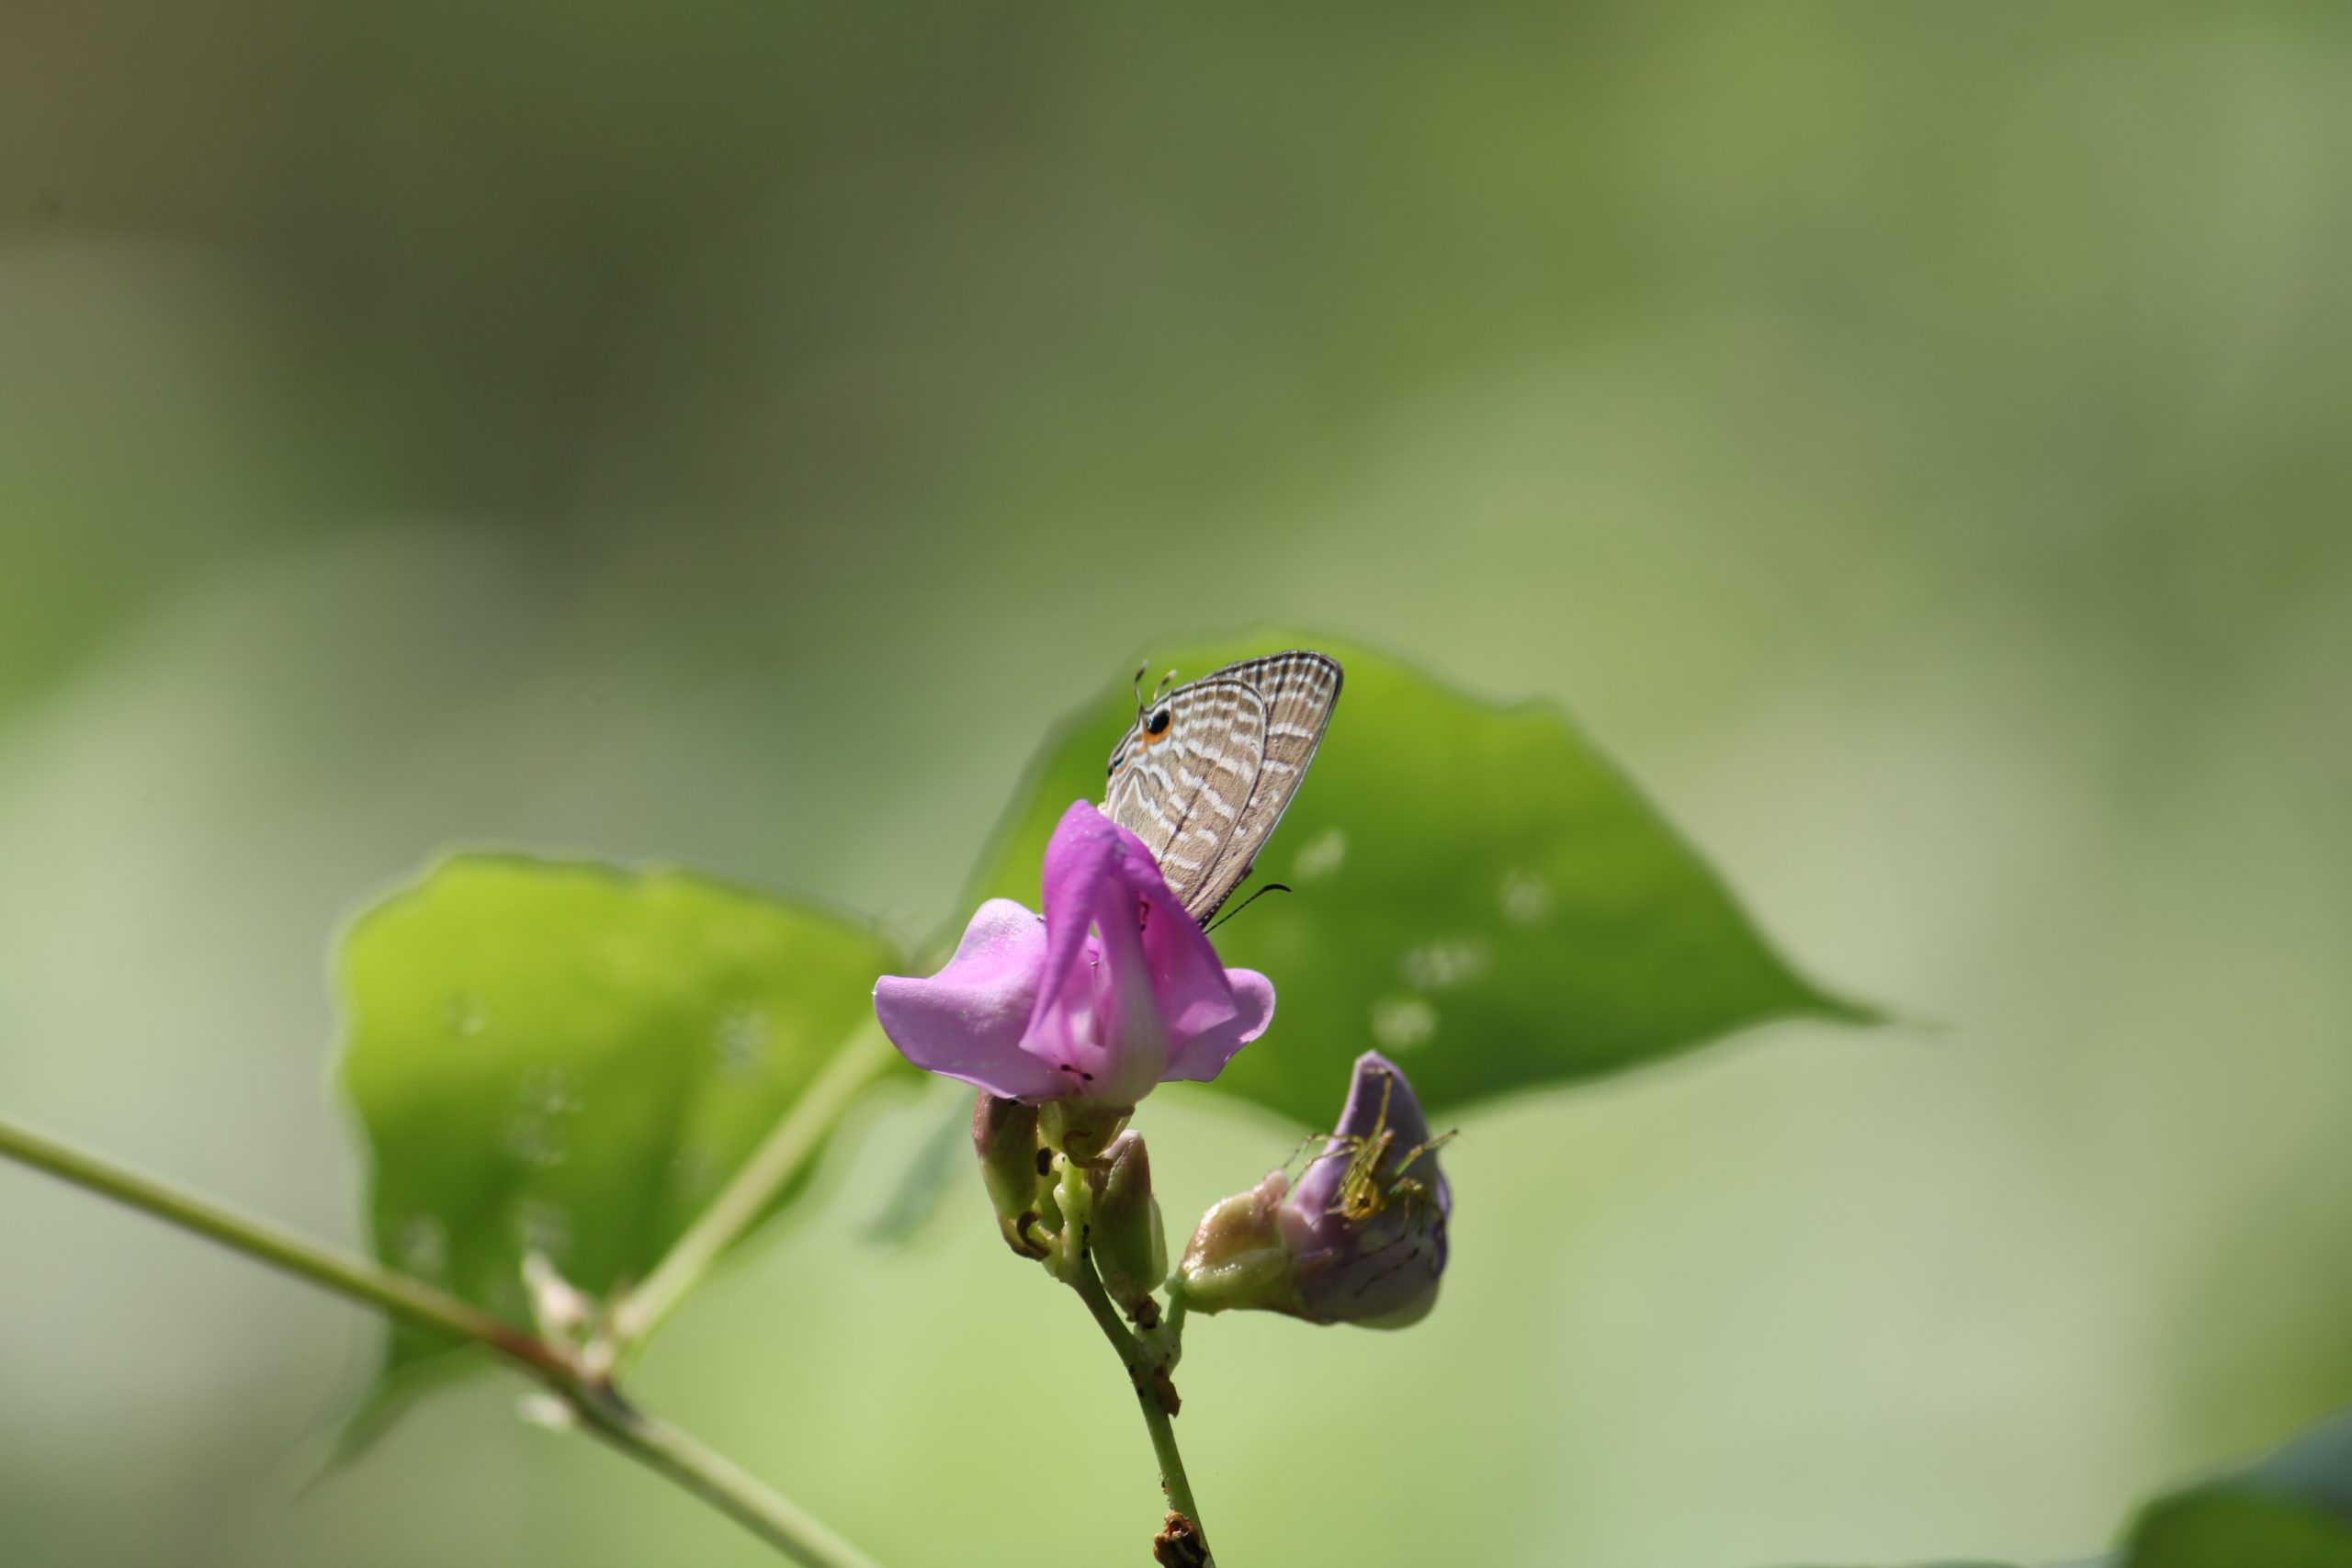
<box><xmin>1183</xmin><ymin>1051</ymin><xmax>1453</xmax><ymax>1328</ymax></box>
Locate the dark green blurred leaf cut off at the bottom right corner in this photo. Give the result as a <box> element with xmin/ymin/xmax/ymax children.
<box><xmin>2124</xmin><ymin>1416</ymin><xmax>2352</xmax><ymax>1568</ymax></box>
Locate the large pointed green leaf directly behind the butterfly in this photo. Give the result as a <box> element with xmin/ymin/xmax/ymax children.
<box><xmin>967</xmin><ymin>632</ymin><xmax>1872</xmax><ymax>1126</ymax></box>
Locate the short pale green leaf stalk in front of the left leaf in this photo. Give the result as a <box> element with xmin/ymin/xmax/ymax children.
<box><xmin>612</xmin><ymin>1021</ymin><xmax>896</xmax><ymax>1366</ymax></box>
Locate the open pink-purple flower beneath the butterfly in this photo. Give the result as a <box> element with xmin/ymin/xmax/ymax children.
<box><xmin>875</xmin><ymin>802</ymin><xmax>1275</xmax><ymax>1107</ymax></box>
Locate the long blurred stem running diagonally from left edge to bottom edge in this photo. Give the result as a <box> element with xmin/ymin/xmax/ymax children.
<box><xmin>0</xmin><ymin>1122</ymin><xmax>875</xmax><ymax>1568</ymax></box>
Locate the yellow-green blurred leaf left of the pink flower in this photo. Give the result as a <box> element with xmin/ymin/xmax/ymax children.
<box><xmin>339</xmin><ymin>856</ymin><xmax>900</xmax><ymax>1413</ymax></box>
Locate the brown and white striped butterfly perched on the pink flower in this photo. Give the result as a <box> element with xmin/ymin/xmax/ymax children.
<box><xmin>1103</xmin><ymin>649</ymin><xmax>1340</xmax><ymax>924</ymax></box>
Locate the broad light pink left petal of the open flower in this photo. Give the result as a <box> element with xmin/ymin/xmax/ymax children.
<box><xmin>875</xmin><ymin>898</ymin><xmax>1066</xmax><ymax>1100</ymax></box>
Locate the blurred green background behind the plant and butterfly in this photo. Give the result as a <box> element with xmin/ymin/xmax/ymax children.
<box><xmin>0</xmin><ymin>0</ymin><xmax>2352</xmax><ymax>1568</ymax></box>
